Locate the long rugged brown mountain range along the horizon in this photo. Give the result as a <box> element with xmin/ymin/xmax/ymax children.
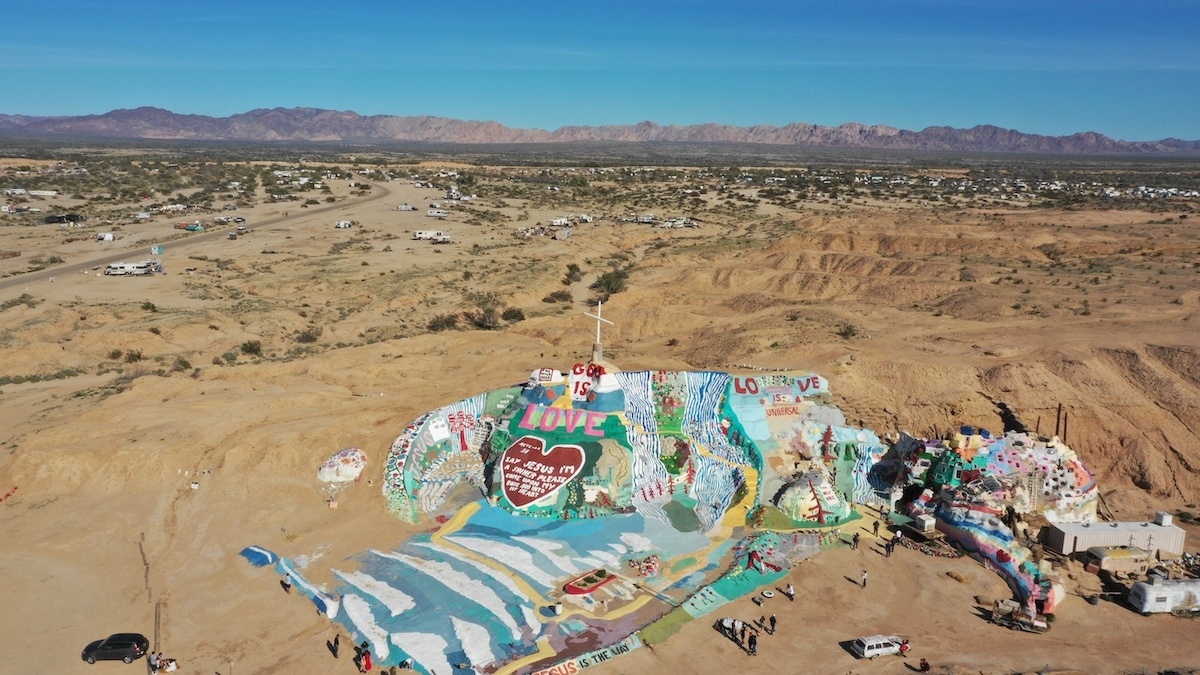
<box><xmin>0</xmin><ymin>107</ymin><xmax>1200</xmax><ymax>155</ymax></box>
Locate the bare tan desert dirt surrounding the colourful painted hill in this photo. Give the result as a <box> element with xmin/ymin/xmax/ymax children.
<box><xmin>0</xmin><ymin>164</ymin><xmax>1200</xmax><ymax>675</ymax></box>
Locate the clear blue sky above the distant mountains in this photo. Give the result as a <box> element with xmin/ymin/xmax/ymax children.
<box><xmin>0</xmin><ymin>0</ymin><xmax>1200</xmax><ymax>141</ymax></box>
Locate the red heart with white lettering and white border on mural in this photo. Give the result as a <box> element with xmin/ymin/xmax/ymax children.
<box><xmin>500</xmin><ymin>436</ymin><xmax>583</xmax><ymax>508</ymax></box>
